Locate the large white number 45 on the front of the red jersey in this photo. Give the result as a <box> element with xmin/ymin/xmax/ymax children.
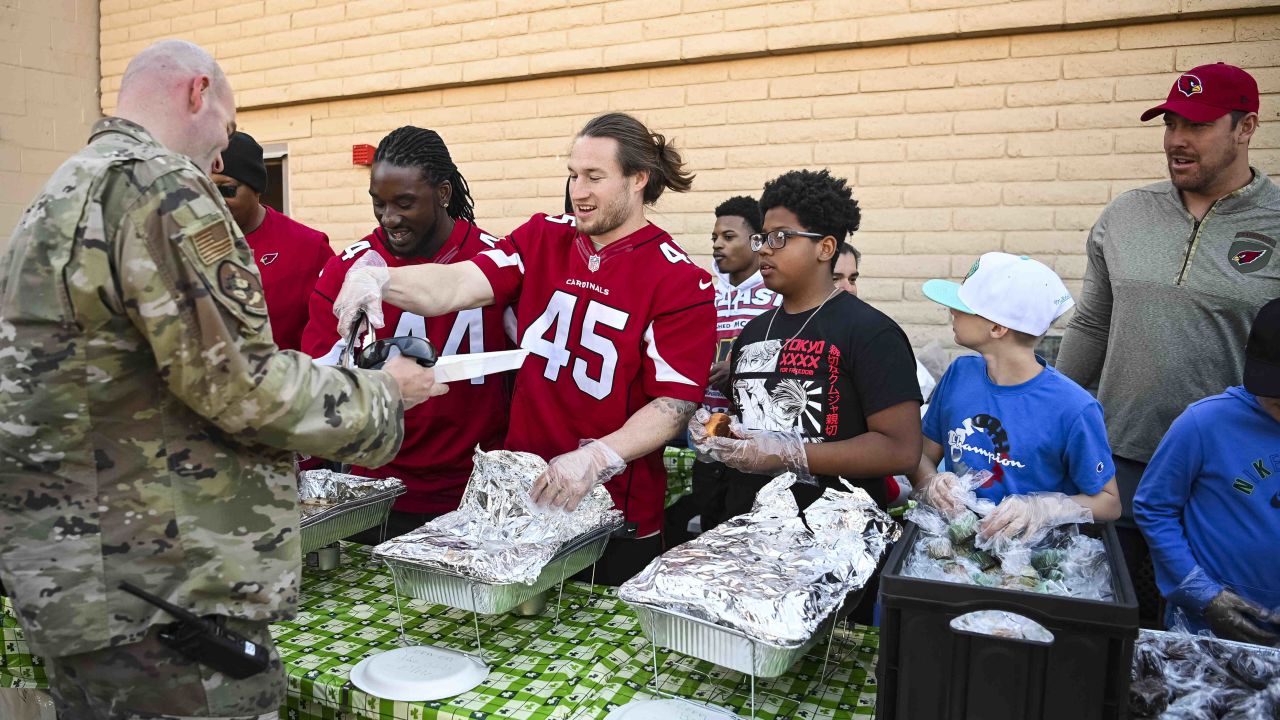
<box><xmin>520</xmin><ymin>290</ymin><xmax>630</xmax><ymax>400</ymax></box>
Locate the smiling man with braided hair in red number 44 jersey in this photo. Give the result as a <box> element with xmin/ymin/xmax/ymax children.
<box><xmin>302</xmin><ymin>126</ymin><xmax>509</xmax><ymax>535</ymax></box>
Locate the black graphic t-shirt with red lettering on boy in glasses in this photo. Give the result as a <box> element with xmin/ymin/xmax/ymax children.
<box><xmin>726</xmin><ymin>292</ymin><xmax>922</xmax><ymax>516</ymax></box>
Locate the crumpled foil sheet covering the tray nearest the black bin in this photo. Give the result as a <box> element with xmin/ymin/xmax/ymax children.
<box><xmin>618</xmin><ymin>473</ymin><xmax>901</xmax><ymax>645</ymax></box>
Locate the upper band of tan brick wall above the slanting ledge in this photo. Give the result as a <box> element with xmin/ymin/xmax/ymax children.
<box><xmin>101</xmin><ymin>0</ymin><xmax>1280</xmax><ymax>109</ymax></box>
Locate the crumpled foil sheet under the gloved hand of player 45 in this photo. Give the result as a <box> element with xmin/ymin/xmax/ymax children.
<box><xmin>374</xmin><ymin>450</ymin><xmax>622</xmax><ymax>585</ymax></box>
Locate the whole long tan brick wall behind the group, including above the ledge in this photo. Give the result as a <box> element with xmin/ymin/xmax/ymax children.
<box><xmin>102</xmin><ymin>0</ymin><xmax>1280</xmax><ymax>345</ymax></box>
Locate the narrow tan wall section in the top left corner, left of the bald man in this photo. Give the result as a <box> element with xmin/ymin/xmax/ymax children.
<box><xmin>0</xmin><ymin>0</ymin><xmax>100</xmax><ymax>252</ymax></box>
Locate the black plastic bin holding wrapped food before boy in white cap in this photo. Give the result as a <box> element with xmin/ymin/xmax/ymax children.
<box><xmin>876</xmin><ymin>524</ymin><xmax>1138</xmax><ymax>720</ymax></box>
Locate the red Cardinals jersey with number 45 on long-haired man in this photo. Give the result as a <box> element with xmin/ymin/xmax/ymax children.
<box><xmin>475</xmin><ymin>215</ymin><xmax>716</xmax><ymax>537</ymax></box>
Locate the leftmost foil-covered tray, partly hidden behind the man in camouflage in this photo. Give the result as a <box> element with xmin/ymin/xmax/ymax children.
<box><xmin>298</xmin><ymin>470</ymin><xmax>404</xmax><ymax>555</ymax></box>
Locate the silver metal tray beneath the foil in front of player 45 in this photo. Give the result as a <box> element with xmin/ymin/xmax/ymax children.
<box><xmin>381</xmin><ymin>523</ymin><xmax>622</xmax><ymax>615</ymax></box>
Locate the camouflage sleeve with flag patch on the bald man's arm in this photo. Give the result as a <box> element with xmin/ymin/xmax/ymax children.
<box><xmin>115</xmin><ymin>172</ymin><xmax>404</xmax><ymax>466</ymax></box>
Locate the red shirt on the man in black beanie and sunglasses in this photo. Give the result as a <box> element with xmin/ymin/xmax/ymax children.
<box><xmin>244</xmin><ymin>205</ymin><xmax>333</xmax><ymax>350</ymax></box>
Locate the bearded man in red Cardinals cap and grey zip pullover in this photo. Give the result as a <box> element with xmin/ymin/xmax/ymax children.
<box><xmin>1057</xmin><ymin>63</ymin><xmax>1280</xmax><ymax>623</ymax></box>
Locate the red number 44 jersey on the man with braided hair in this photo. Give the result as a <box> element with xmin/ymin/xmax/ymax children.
<box><xmin>302</xmin><ymin>220</ymin><xmax>511</xmax><ymax>512</ymax></box>
